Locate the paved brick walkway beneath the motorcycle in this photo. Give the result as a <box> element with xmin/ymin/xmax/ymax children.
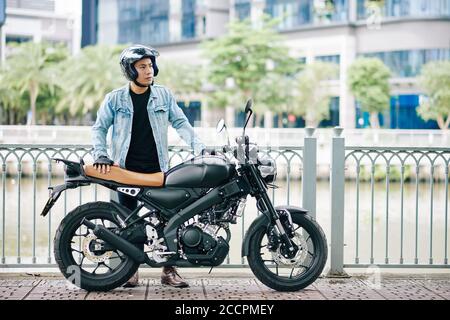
<box><xmin>0</xmin><ymin>272</ymin><xmax>450</xmax><ymax>300</ymax></box>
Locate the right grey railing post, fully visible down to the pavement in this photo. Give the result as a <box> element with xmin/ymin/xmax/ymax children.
<box><xmin>328</xmin><ymin>127</ymin><xmax>348</xmax><ymax>277</ymax></box>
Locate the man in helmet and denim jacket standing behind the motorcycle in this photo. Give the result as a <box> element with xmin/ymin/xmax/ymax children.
<box><xmin>92</xmin><ymin>45</ymin><xmax>206</xmax><ymax>287</ymax></box>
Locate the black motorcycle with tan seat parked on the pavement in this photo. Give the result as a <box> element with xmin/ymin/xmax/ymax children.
<box><xmin>41</xmin><ymin>100</ymin><xmax>327</xmax><ymax>291</ymax></box>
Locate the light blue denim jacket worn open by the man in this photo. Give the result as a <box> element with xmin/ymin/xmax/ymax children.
<box><xmin>92</xmin><ymin>85</ymin><xmax>205</xmax><ymax>172</ymax></box>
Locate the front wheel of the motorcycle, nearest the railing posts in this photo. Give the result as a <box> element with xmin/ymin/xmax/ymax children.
<box><xmin>247</xmin><ymin>214</ymin><xmax>328</xmax><ymax>291</ymax></box>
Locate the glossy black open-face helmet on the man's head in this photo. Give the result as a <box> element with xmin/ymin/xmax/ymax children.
<box><xmin>120</xmin><ymin>44</ymin><xmax>159</xmax><ymax>87</ymax></box>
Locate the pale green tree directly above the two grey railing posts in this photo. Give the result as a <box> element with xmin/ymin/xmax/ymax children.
<box><xmin>290</xmin><ymin>61</ymin><xmax>339</xmax><ymax>127</ymax></box>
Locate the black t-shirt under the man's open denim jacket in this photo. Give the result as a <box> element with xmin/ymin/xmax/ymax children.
<box><xmin>125</xmin><ymin>88</ymin><xmax>161</xmax><ymax>173</ymax></box>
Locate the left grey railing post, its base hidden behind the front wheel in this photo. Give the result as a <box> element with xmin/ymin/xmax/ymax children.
<box><xmin>302</xmin><ymin>127</ymin><xmax>317</xmax><ymax>218</ymax></box>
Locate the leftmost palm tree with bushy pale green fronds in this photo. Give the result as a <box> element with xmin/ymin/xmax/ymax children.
<box><xmin>2</xmin><ymin>42</ymin><xmax>68</xmax><ymax>125</ymax></box>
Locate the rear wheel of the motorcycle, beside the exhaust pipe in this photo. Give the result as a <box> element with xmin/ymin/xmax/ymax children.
<box><xmin>54</xmin><ymin>202</ymin><xmax>139</xmax><ymax>291</ymax></box>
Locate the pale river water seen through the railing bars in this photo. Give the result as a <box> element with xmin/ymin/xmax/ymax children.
<box><xmin>0</xmin><ymin>178</ymin><xmax>448</xmax><ymax>267</ymax></box>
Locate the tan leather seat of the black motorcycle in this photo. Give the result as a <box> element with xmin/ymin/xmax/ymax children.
<box><xmin>84</xmin><ymin>165</ymin><xmax>164</xmax><ymax>187</ymax></box>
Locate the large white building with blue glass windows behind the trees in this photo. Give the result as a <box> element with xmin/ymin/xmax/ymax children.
<box><xmin>86</xmin><ymin>0</ymin><xmax>450</xmax><ymax>129</ymax></box>
